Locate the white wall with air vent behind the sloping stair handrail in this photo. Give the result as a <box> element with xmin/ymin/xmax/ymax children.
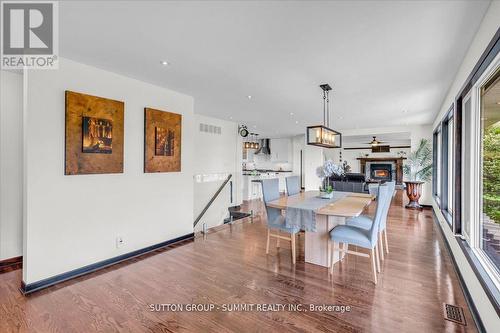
<box><xmin>193</xmin><ymin>115</ymin><xmax>242</xmax><ymax>231</ymax></box>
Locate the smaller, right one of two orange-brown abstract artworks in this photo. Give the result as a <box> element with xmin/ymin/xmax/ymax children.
<box><xmin>144</xmin><ymin>108</ymin><xmax>182</xmax><ymax>173</ymax></box>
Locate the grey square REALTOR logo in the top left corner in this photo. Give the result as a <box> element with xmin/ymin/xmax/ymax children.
<box><xmin>1</xmin><ymin>1</ymin><xmax>58</xmax><ymax>69</ymax></box>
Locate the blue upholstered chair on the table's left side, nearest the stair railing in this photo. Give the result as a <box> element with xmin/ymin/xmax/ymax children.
<box><xmin>262</xmin><ymin>178</ymin><xmax>300</xmax><ymax>265</ymax></box>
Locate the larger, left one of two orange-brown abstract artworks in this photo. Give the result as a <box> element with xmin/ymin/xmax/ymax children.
<box><xmin>65</xmin><ymin>91</ymin><xmax>124</xmax><ymax>175</ymax></box>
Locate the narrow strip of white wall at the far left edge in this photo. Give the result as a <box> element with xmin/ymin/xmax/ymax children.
<box><xmin>0</xmin><ymin>70</ymin><xmax>23</xmax><ymax>260</ymax></box>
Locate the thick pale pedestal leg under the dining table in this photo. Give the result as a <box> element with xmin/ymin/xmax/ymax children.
<box><xmin>305</xmin><ymin>214</ymin><xmax>345</xmax><ymax>267</ymax></box>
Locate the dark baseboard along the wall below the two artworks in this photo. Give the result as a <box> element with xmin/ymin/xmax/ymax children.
<box><xmin>20</xmin><ymin>233</ymin><xmax>194</xmax><ymax>295</ymax></box>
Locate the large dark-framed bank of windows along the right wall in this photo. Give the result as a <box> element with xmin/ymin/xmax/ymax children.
<box><xmin>442</xmin><ymin>30</ymin><xmax>500</xmax><ymax>313</ymax></box>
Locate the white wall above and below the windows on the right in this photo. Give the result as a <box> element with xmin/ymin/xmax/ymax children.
<box><xmin>433</xmin><ymin>1</ymin><xmax>500</xmax><ymax>332</ymax></box>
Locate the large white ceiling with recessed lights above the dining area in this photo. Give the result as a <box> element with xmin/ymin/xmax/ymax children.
<box><xmin>59</xmin><ymin>0</ymin><xmax>489</xmax><ymax>136</ymax></box>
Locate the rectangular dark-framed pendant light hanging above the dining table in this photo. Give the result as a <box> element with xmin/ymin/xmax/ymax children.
<box><xmin>306</xmin><ymin>84</ymin><xmax>342</xmax><ymax>148</ymax></box>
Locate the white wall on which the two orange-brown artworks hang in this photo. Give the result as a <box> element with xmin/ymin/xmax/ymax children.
<box><xmin>23</xmin><ymin>59</ymin><xmax>195</xmax><ymax>283</ymax></box>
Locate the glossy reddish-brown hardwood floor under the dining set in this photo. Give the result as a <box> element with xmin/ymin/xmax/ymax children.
<box><xmin>0</xmin><ymin>193</ymin><xmax>476</xmax><ymax>333</ymax></box>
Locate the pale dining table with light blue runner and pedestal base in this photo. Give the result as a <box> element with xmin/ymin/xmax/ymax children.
<box><xmin>267</xmin><ymin>191</ymin><xmax>375</xmax><ymax>267</ymax></box>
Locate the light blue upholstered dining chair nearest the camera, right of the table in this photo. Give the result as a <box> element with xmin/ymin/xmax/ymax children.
<box><xmin>330</xmin><ymin>185</ymin><xmax>391</xmax><ymax>284</ymax></box>
